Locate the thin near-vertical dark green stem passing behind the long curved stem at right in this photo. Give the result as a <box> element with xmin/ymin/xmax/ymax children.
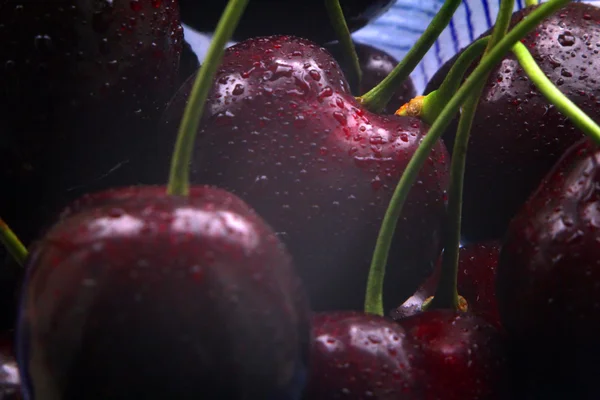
<box><xmin>428</xmin><ymin>0</ymin><xmax>515</xmax><ymax>310</ymax></box>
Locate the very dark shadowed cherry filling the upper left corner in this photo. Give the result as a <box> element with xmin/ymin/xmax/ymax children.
<box><xmin>0</xmin><ymin>0</ymin><xmax>183</xmax><ymax>256</ymax></box>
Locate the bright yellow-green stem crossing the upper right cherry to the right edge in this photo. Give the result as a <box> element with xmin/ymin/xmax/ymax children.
<box><xmin>512</xmin><ymin>43</ymin><xmax>600</xmax><ymax>144</ymax></box>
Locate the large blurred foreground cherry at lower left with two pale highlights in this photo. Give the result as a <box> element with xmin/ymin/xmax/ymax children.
<box><xmin>17</xmin><ymin>186</ymin><xmax>310</xmax><ymax>399</ymax></box>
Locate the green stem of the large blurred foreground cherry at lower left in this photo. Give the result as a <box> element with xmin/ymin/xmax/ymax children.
<box><xmin>167</xmin><ymin>0</ymin><xmax>248</xmax><ymax>196</ymax></box>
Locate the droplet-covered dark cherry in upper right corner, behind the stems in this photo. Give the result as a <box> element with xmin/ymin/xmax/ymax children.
<box><xmin>426</xmin><ymin>2</ymin><xmax>600</xmax><ymax>241</ymax></box>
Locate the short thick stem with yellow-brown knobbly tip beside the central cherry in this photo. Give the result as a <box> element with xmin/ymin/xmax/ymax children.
<box><xmin>396</xmin><ymin>36</ymin><xmax>490</xmax><ymax>125</ymax></box>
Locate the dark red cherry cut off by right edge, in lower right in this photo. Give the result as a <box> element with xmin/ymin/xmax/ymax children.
<box><xmin>497</xmin><ymin>139</ymin><xmax>600</xmax><ymax>399</ymax></box>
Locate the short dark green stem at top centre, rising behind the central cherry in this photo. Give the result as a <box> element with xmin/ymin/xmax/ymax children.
<box><xmin>325</xmin><ymin>0</ymin><xmax>362</xmax><ymax>90</ymax></box>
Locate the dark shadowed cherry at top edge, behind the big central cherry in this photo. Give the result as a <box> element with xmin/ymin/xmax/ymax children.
<box><xmin>179</xmin><ymin>0</ymin><xmax>394</xmax><ymax>44</ymax></box>
